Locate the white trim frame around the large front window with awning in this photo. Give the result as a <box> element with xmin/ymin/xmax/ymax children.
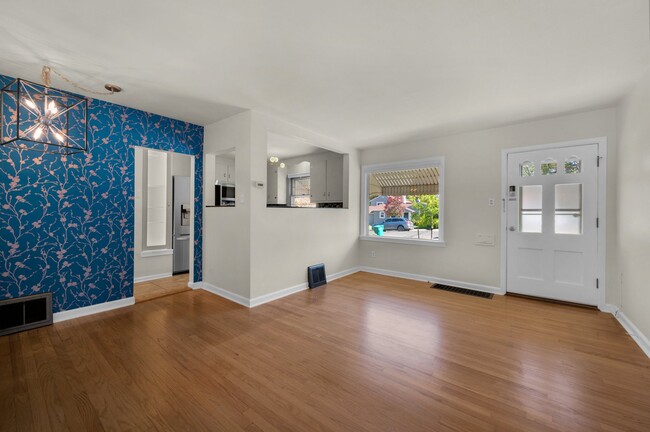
<box><xmin>359</xmin><ymin>156</ymin><xmax>446</xmax><ymax>247</ymax></box>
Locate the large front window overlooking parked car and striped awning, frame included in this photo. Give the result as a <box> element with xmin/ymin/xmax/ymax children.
<box><xmin>360</xmin><ymin>157</ymin><xmax>444</xmax><ymax>246</ymax></box>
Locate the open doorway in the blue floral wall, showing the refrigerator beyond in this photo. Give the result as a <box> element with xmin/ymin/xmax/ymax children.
<box><xmin>133</xmin><ymin>147</ymin><xmax>194</xmax><ymax>302</ymax></box>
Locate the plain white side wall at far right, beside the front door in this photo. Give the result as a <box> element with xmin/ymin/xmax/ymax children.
<box><xmin>617</xmin><ymin>68</ymin><xmax>650</xmax><ymax>338</ymax></box>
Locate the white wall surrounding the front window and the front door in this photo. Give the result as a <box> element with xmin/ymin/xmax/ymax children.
<box><xmin>357</xmin><ymin>108</ymin><xmax>618</xmax><ymax>302</ymax></box>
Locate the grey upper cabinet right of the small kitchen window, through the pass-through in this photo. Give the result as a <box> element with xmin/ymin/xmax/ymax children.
<box><xmin>310</xmin><ymin>153</ymin><xmax>343</xmax><ymax>203</ymax></box>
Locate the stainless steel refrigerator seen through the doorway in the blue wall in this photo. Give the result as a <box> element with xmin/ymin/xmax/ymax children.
<box><xmin>172</xmin><ymin>176</ymin><xmax>192</xmax><ymax>274</ymax></box>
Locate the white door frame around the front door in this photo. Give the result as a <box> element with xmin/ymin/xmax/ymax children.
<box><xmin>501</xmin><ymin>137</ymin><xmax>608</xmax><ymax>312</ymax></box>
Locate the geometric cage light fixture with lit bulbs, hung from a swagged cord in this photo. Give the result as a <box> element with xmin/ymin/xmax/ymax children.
<box><xmin>0</xmin><ymin>66</ymin><xmax>122</xmax><ymax>154</ymax></box>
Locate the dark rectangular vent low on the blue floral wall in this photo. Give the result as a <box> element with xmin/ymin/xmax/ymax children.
<box><xmin>0</xmin><ymin>293</ymin><xmax>52</xmax><ymax>336</ymax></box>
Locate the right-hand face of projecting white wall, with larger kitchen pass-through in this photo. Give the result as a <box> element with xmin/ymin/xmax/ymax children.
<box><xmin>251</xmin><ymin>112</ymin><xmax>360</xmax><ymax>298</ymax></box>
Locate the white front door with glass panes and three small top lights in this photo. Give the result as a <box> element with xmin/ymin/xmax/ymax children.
<box><xmin>506</xmin><ymin>144</ymin><xmax>598</xmax><ymax>305</ymax></box>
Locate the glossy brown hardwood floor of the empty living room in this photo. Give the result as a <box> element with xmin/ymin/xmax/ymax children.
<box><xmin>0</xmin><ymin>273</ymin><xmax>650</xmax><ymax>432</ymax></box>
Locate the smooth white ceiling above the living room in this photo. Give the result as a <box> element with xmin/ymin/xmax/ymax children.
<box><xmin>0</xmin><ymin>0</ymin><xmax>650</xmax><ymax>147</ymax></box>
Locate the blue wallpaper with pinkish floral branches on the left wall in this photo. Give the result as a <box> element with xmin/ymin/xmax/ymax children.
<box><xmin>0</xmin><ymin>75</ymin><xmax>203</xmax><ymax>312</ymax></box>
